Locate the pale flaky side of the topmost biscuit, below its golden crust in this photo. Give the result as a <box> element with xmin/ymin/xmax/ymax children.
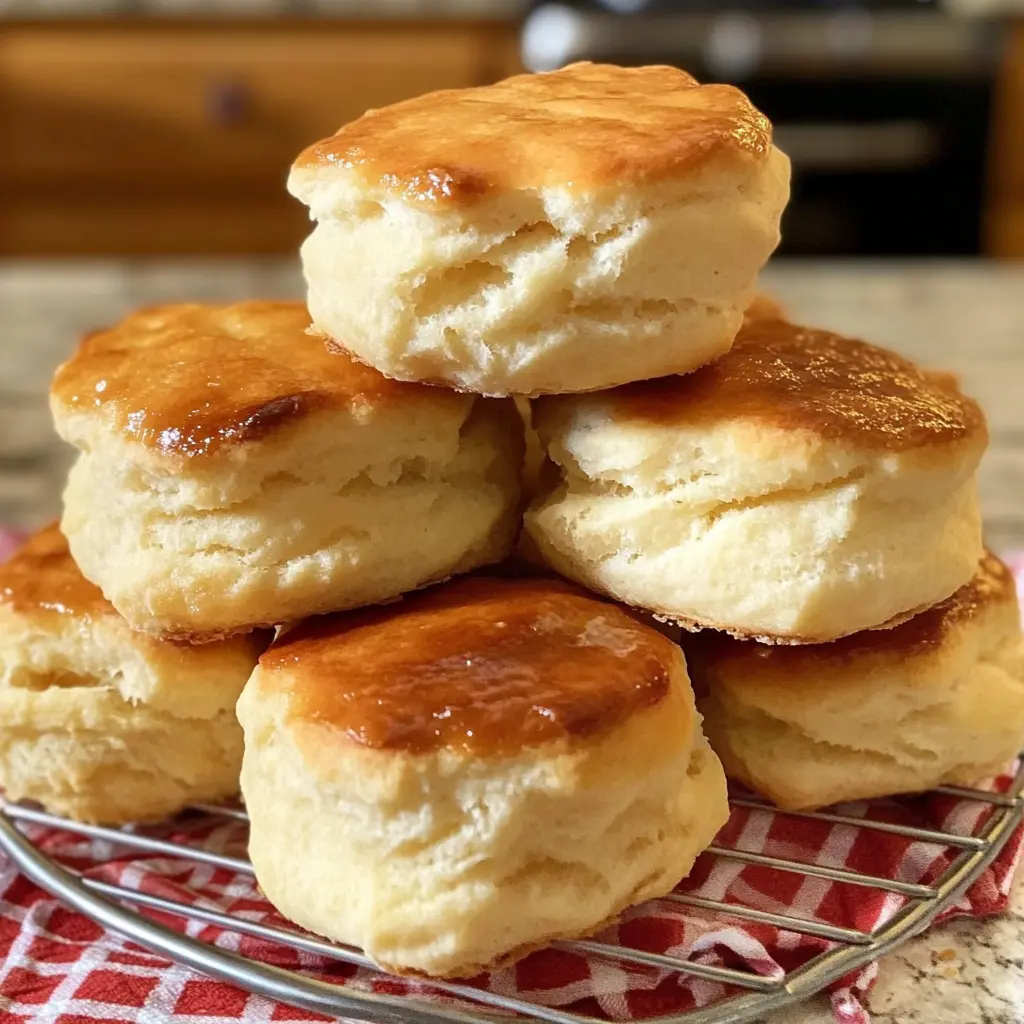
<box><xmin>289</xmin><ymin>148</ymin><xmax>790</xmax><ymax>394</ymax></box>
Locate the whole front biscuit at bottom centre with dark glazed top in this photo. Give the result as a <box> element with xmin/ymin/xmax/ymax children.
<box><xmin>238</xmin><ymin>578</ymin><xmax>728</xmax><ymax>977</ymax></box>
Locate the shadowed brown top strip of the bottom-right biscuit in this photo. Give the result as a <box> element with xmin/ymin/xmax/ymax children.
<box><xmin>683</xmin><ymin>552</ymin><xmax>1017</xmax><ymax>686</ymax></box>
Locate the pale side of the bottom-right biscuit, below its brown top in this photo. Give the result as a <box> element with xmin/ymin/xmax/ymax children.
<box><xmin>700</xmin><ymin>585</ymin><xmax>1024</xmax><ymax>808</ymax></box>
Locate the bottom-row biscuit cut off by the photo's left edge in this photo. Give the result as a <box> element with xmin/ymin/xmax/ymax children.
<box><xmin>0</xmin><ymin>525</ymin><xmax>269</xmax><ymax>824</ymax></box>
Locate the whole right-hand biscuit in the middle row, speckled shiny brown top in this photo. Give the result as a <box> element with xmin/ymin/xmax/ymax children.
<box><xmin>526</xmin><ymin>317</ymin><xmax>987</xmax><ymax>643</ymax></box>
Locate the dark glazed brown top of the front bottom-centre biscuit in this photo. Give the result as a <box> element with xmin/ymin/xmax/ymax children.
<box><xmin>260</xmin><ymin>578</ymin><xmax>679</xmax><ymax>755</ymax></box>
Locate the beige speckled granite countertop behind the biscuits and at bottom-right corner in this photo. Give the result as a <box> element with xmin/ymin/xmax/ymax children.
<box><xmin>0</xmin><ymin>260</ymin><xmax>1024</xmax><ymax>1024</ymax></box>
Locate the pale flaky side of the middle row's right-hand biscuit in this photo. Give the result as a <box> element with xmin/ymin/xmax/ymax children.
<box><xmin>526</xmin><ymin>400</ymin><xmax>982</xmax><ymax>642</ymax></box>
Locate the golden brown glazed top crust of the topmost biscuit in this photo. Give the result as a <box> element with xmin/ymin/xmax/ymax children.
<box><xmin>295</xmin><ymin>63</ymin><xmax>771</xmax><ymax>204</ymax></box>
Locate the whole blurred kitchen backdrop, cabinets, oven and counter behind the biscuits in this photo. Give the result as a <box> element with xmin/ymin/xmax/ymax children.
<box><xmin>0</xmin><ymin>0</ymin><xmax>1024</xmax><ymax>547</ymax></box>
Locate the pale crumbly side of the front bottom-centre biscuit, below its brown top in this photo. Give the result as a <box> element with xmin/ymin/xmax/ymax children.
<box><xmin>239</xmin><ymin>671</ymin><xmax>728</xmax><ymax>976</ymax></box>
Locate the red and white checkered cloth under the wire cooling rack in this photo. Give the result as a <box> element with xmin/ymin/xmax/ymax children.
<box><xmin>0</xmin><ymin>528</ymin><xmax>1024</xmax><ymax>1024</ymax></box>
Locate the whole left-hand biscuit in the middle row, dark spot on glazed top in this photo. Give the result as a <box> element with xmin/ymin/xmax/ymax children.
<box><xmin>51</xmin><ymin>302</ymin><xmax>523</xmax><ymax>641</ymax></box>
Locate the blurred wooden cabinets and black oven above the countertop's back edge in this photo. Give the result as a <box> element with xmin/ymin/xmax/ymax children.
<box><xmin>0</xmin><ymin>0</ymin><xmax>1024</xmax><ymax>257</ymax></box>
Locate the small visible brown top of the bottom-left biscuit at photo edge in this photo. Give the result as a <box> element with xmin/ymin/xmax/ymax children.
<box><xmin>0</xmin><ymin>523</ymin><xmax>111</xmax><ymax>616</ymax></box>
